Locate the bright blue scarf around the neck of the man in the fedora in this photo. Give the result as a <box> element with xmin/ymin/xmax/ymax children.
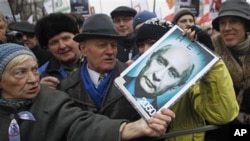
<box><xmin>81</xmin><ymin>62</ymin><xmax>114</xmax><ymax>107</ymax></box>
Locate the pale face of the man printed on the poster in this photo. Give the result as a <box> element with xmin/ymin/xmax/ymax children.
<box><xmin>139</xmin><ymin>47</ymin><xmax>192</xmax><ymax>96</ymax></box>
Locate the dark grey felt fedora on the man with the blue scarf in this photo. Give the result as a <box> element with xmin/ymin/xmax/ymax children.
<box><xmin>74</xmin><ymin>14</ymin><xmax>124</xmax><ymax>42</ymax></box>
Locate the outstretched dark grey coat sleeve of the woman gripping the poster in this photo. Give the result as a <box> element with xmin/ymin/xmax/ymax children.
<box><xmin>38</xmin><ymin>86</ymin><xmax>125</xmax><ymax>141</ymax></box>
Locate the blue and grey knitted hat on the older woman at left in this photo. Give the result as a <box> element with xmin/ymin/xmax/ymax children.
<box><xmin>0</xmin><ymin>43</ymin><xmax>36</xmax><ymax>78</ymax></box>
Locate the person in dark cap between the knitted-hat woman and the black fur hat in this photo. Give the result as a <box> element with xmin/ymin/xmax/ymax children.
<box><xmin>8</xmin><ymin>21</ymin><xmax>52</xmax><ymax>66</ymax></box>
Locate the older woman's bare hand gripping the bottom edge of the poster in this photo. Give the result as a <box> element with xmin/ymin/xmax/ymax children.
<box><xmin>122</xmin><ymin>109</ymin><xmax>175</xmax><ymax>140</ymax></box>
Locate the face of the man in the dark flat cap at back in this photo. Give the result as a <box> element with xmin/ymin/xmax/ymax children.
<box><xmin>113</xmin><ymin>16</ymin><xmax>134</xmax><ymax>36</ymax></box>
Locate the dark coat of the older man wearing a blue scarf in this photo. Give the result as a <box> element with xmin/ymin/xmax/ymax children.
<box><xmin>59</xmin><ymin>61</ymin><xmax>140</xmax><ymax>121</ymax></box>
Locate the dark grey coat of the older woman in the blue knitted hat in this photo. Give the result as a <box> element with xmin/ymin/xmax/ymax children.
<box><xmin>0</xmin><ymin>86</ymin><xmax>123</xmax><ymax>141</ymax></box>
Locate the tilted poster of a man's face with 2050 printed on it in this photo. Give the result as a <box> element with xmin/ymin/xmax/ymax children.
<box><xmin>115</xmin><ymin>26</ymin><xmax>219</xmax><ymax>119</ymax></box>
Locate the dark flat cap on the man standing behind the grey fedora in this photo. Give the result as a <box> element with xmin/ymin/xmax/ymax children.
<box><xmin>110</xmin><ymin>6</ymin><xmax>137</xmax><ymax>18</ymax></box>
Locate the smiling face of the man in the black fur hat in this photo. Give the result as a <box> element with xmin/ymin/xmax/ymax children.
<box><xmin>48</xmin><ymin>32</ymin><xmax>81</xmax><ymax>65</ymax></box>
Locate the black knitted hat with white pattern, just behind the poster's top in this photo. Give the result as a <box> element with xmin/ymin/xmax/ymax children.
<box><xmin>136</xmin><ymin>18</ymin><xmax>174</xmax><ymax>44</ymax></box>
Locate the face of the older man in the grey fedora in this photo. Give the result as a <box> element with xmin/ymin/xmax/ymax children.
<box><xmin>80</xmin><ymin>38</ymin><xmax>117</xmax><ymax>73</ymax></box>
